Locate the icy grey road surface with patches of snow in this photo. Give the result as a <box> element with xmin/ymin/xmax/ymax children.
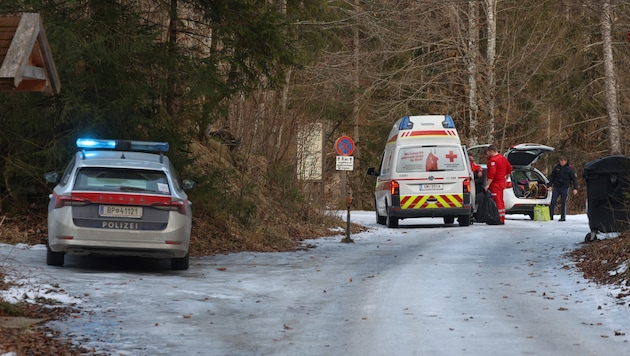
<box><xmin>0</xmin><ymin>211</ymin><xmax>630</xmax><ymax>356</ymax></box>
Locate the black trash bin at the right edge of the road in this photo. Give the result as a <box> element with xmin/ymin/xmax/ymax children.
<box><xmin>584</xmin><ymin>156</ymin><xmax>630</xmax><ymax>242</ymax></box>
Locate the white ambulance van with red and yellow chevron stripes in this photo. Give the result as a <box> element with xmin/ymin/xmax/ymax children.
<box><xmin>367</xmin><ymin>115</ymin><xmax>475</xmax><ymax>228</ymax></box>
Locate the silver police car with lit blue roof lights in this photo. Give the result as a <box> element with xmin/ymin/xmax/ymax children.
<box><xmin>44</xmin><ymin>138</ymin><xmax>195</xmax><ymax>270</ymax></box>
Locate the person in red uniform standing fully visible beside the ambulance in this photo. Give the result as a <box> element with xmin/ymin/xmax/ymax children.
<box><xmin>484</xmin><ymin>145</ymin><xmax>512</xmax><ymax>224</ymax></box>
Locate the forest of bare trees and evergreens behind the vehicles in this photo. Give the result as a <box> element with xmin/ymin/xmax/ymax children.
<box><xmin>0</xmin><ymin>0</ymin><xmax>630</xmax><ymax>254</ymax></box>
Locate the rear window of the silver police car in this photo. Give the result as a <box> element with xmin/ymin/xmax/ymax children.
<box><xmin>74</xmin><ymin>167</ymin><xmax>170</xmax><ymax>194</ymax></box>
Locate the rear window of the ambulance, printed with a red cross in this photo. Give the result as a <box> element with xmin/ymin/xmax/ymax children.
<box><xmin>396</xmin><ymin>146</ymin><xmax>466</xmax><ymax>173</ymax></box>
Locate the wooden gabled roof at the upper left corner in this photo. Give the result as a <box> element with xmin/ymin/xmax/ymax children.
<box><xmin>0</xmin><ymin>13</ymin><xmax>60</xmax><ymax>94</ymax></box>
